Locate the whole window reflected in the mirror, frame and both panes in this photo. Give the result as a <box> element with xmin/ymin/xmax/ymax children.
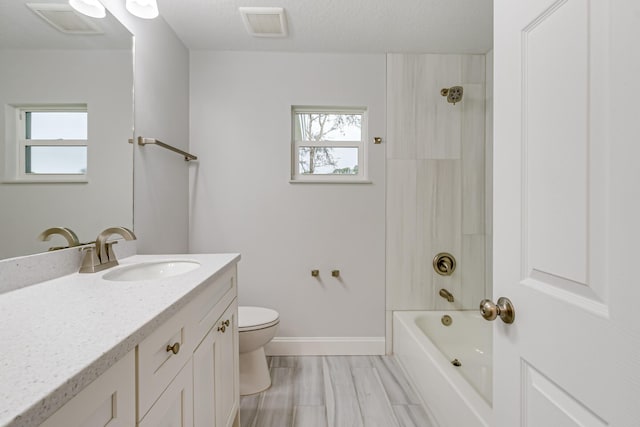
<box><xmin>8</xmin><ymin>105</ymin><xmax>88</xmax><ymax>182</ymax></box>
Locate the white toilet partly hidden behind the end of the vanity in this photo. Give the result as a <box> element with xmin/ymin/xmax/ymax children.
<box><xmin>238</xmin><ymin>306</ymin><xmax>280</xmax><ymax>396</ymax></box>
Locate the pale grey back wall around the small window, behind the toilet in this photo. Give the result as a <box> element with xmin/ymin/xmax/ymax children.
<box><xmin>189</xmin><ymin>51</ymin><xmax>385</xmax><ymax>351</ymax></box>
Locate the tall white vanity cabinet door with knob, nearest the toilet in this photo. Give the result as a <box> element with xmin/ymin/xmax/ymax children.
<box><xmin>193</xmin><ymin>300</ymin><xmax>239</xmax><ymax>427</ymax></box>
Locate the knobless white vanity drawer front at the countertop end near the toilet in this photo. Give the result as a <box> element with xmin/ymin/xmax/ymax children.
<box><xmin>189</xmin><ymin>265</ymin><xmax>238</xmax><ymax>347</ymax></box>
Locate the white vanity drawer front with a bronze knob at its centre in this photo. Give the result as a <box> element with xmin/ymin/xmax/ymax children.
<box><xmin>137</xmin><ymin>305</ymin><xmax>194</xmax><ymax>418</ymax></box>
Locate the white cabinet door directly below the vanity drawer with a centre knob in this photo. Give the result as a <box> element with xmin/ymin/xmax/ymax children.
<box><xmin>138</xmin><ymin>359</ymin><xmax>193</xmax><ymax>427</ymax></box>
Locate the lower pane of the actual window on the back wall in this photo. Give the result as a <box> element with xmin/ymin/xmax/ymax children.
<box><xmin>298</xmin><ymin>147</ymin><xmax>358</xmax><ymax>175</ymax></box>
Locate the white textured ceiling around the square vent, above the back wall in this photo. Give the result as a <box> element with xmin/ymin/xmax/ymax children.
<box><xmin>158</xmin><ymin>0</ymin><xmax>493</xmax><ymax>53</ymax></box>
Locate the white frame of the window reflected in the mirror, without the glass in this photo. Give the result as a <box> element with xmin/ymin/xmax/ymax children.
<box><xmin>5</xmin><ymin>104</ymin><xmax>90</xmax><ymax>183</ymax></box>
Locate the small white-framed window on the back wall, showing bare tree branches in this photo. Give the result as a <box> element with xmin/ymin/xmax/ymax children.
<box><xmin>291</xmin><ymin>107</ymin><xmax>366</xmax><ymax>182</ymax></box>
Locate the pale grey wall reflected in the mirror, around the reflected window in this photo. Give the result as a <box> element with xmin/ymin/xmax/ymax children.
<box><xmin>0</xmin><ymin>49</ymin><xmax>133</xmax><ymax>259</ymax></box>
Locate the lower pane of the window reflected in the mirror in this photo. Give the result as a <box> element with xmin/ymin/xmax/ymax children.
<box><xmin>25</xmin><ymin>145</ymin><xmax>87</xmax><ymax>174</ymax></box>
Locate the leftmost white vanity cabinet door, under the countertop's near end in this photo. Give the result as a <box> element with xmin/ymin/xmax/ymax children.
<box><xmin>41</xmin><ymin>351</ymin><xmax>136</xmax><ymax>427</ymax></box>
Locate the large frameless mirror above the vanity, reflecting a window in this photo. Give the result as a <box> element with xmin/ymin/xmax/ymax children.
<box><xmin>0</xmin><ymin>0</ymin><xmax>133</xmax><ymax>259</ymax></box>
